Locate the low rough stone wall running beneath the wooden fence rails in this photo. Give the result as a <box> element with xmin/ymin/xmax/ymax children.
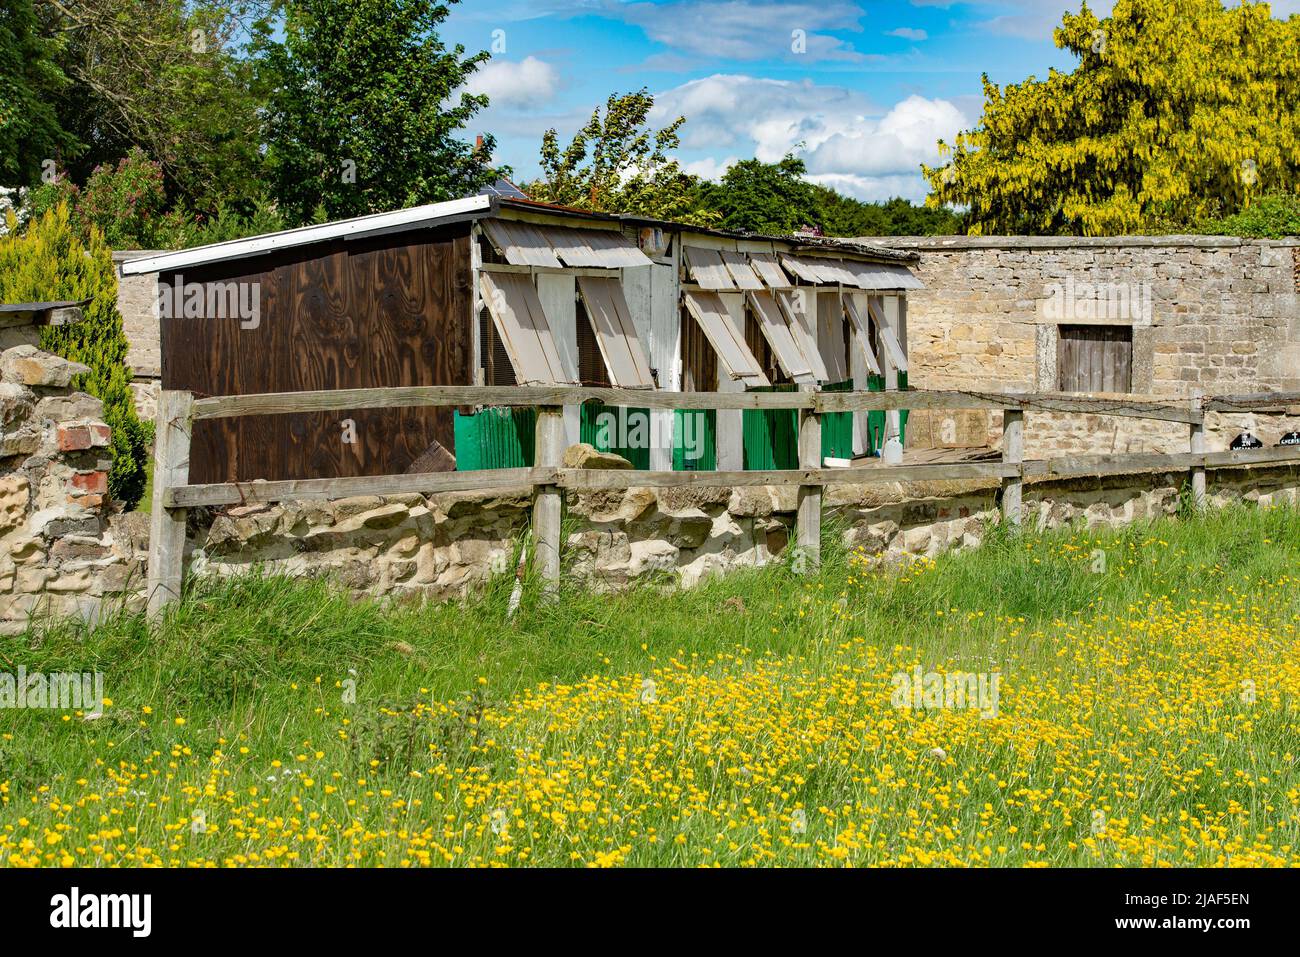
<box><xmin>170</xmin><ymin>465</ymin><xmax>1300</xmax><ymax>599</ymax></box>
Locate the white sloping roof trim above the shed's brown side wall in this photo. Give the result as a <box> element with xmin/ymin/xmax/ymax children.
<box><xmin>122</xmin><ymin>195</ymin><xmax>493</xmax><ymax>276</ymax></box>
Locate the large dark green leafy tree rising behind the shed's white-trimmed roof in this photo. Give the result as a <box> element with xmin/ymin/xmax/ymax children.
<box><xmin>257</xmin><ymin>0</ymin><xmax>497</xmax><ymax>222</ymax></box>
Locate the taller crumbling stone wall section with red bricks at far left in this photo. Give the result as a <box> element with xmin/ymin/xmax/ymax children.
<box><xmin>0</xmin><ymin>345</ymin><xmax>143</xmax><ymax>635</ymax></box>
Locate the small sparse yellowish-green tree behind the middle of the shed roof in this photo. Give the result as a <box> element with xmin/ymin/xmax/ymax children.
<box><xmin>524</xmin><ymin>88</ymin><xmax>715</xmax><ymax>225</ymax></box>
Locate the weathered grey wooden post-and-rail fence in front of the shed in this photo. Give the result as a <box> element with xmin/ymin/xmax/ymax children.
<box><xmin>148</xmin><ymin>386</ymin><xmax>1300</xmax><ymax>614</ymax></box>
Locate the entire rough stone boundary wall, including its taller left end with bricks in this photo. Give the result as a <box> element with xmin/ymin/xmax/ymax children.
<box><xmin>0</xmin><ymin>345</ymin><xmax>1300</xmax><ymax>635</ymax></box>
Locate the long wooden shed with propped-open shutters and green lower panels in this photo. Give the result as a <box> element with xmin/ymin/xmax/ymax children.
<box><xmin>122</xmin><ymin>195</ymin><xmax>920</xmax><ymax>482</ymax></box>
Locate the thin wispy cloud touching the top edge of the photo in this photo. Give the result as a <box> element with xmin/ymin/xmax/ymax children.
<box><xmin>599</xmin><ymin>0</ymin><xmax>871</xmax><ymax>61</ymax></box>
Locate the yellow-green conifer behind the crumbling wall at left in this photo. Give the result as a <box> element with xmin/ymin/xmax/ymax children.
<box><xmin>0</xmin><ymin>205</ymin><xmax>151</xmax><ymax>508</ymax></box>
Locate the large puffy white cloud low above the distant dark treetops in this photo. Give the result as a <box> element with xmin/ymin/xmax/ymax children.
<box><xmin>651</xmin><ymin>74</ymin><xmax>972</xmax><ymax>199</ymax></box>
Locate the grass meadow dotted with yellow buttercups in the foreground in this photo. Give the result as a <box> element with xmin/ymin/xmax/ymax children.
<box><xmin>0</xmin><ymin>508</ymin><xmax>1300</xmax><ymax>866</ymax></box>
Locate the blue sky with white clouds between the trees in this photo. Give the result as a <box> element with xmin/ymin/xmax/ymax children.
<box><xmin>442</xmin><ymin>0</ymin><xmax>1300</xmax><ymax>200</ymax></box>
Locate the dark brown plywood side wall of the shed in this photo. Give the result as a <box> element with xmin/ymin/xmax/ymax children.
<box><xmin>159</xmin><ymin>225</ymin><xmax>473</xmax><ymax>484</ymax></box>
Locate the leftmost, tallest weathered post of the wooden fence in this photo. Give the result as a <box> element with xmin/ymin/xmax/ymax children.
<box><xmin>148</xmin><ymin>389</ymin><xmax>194</xmax><ymax>618</ymax></box>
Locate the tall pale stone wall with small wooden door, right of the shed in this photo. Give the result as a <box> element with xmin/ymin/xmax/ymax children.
<box><xmin>865</xmin><ymin>235</ymin><xmax>1300</xmax><ymax>458</ymax></box>
